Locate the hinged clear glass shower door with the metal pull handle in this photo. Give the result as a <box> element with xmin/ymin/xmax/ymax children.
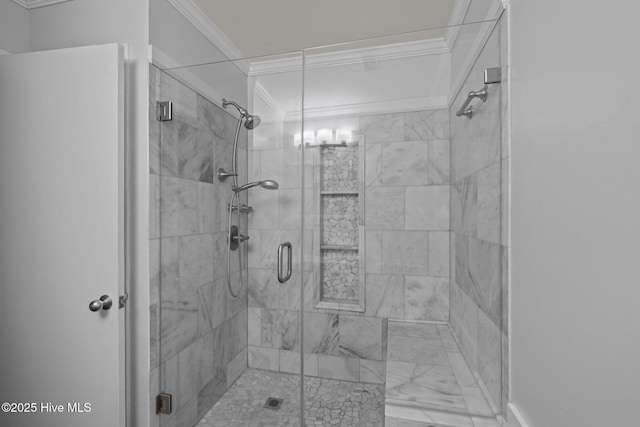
<box><xmin>150</xmin><ymin>51</ymin><xmax>303</xmax><ymax>426</ymax></box>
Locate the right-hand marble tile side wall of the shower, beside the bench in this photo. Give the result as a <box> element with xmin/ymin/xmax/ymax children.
<box><xmin>450</xmin><ymin>19</ymin><xmax>508</xmax><ymax>413</ymax></box>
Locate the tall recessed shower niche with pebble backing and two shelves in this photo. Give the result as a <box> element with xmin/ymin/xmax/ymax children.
<box><xmin>314</xmin><ymin>136</ymin><xmax>365</xmax><ymax>312</ymax></box>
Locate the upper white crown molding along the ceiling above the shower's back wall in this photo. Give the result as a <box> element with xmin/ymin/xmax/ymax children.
<box><xmin>249</xmin><ymin>38</ymin><xmax>450</xmax><ymax>76</ymax></box>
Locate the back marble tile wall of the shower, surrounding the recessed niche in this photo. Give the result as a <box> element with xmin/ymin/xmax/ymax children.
<box><xmin>248</xmin><ymin>109</ymin><xmax>450</xmax><ymax>383</ymax></box>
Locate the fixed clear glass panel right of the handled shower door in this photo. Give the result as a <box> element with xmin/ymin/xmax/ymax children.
<box><xmin>299</xmin><ymin>15</ymin><xmax>503</xmax><ymax>426</ymax></box>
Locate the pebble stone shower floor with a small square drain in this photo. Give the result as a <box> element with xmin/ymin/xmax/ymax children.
<box><xmin>197</xmin><ymin>368</ymin><xmax>384</xmax><ymax>427</ymax></box>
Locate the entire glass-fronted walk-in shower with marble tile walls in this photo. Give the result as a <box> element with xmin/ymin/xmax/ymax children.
<box><xmin>149</xmin><ymin>10</ymin><xmax>508</xmax><ymax>427</ymax></box>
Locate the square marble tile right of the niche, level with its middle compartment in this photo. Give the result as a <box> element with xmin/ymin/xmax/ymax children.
<box><xmin>365</xmin><ymin>187</ymin><xmax>405</xmax><ymax>230</ymax></box>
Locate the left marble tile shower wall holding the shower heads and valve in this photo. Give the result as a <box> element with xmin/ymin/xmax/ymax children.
<box><xmin>149</xmin><ymin>66</ymin><xmax>248</xmax><ymax>426</ymax></box>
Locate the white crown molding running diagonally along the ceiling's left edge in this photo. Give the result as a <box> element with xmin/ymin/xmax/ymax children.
<box><xmin>167</xmin><ymin>0</ymin><xmax>249</xmax><ymax>75</ymax></box>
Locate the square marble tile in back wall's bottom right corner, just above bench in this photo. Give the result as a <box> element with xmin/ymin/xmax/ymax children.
<box><xmin>404</xmin><ymin>276</ymin><xmax>449</xmax><ymax>321</ymax></box>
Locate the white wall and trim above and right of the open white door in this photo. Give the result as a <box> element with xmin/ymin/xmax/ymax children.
<box><xmin>29</xmin><ymin>0</ymin><xmax>149</xmax><ymax>426</ymax></box>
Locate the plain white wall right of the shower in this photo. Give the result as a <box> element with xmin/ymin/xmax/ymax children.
<box><xmin>511</xmin><ymin>0</ymin><xmax>640</xmax><ymax>427</ymax></box>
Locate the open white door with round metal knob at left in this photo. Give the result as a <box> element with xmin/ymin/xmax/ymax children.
<box><xmin>0</xmin><ymin>44</ymin><xmax>125</xmax><ymax>427</ymax></box>
